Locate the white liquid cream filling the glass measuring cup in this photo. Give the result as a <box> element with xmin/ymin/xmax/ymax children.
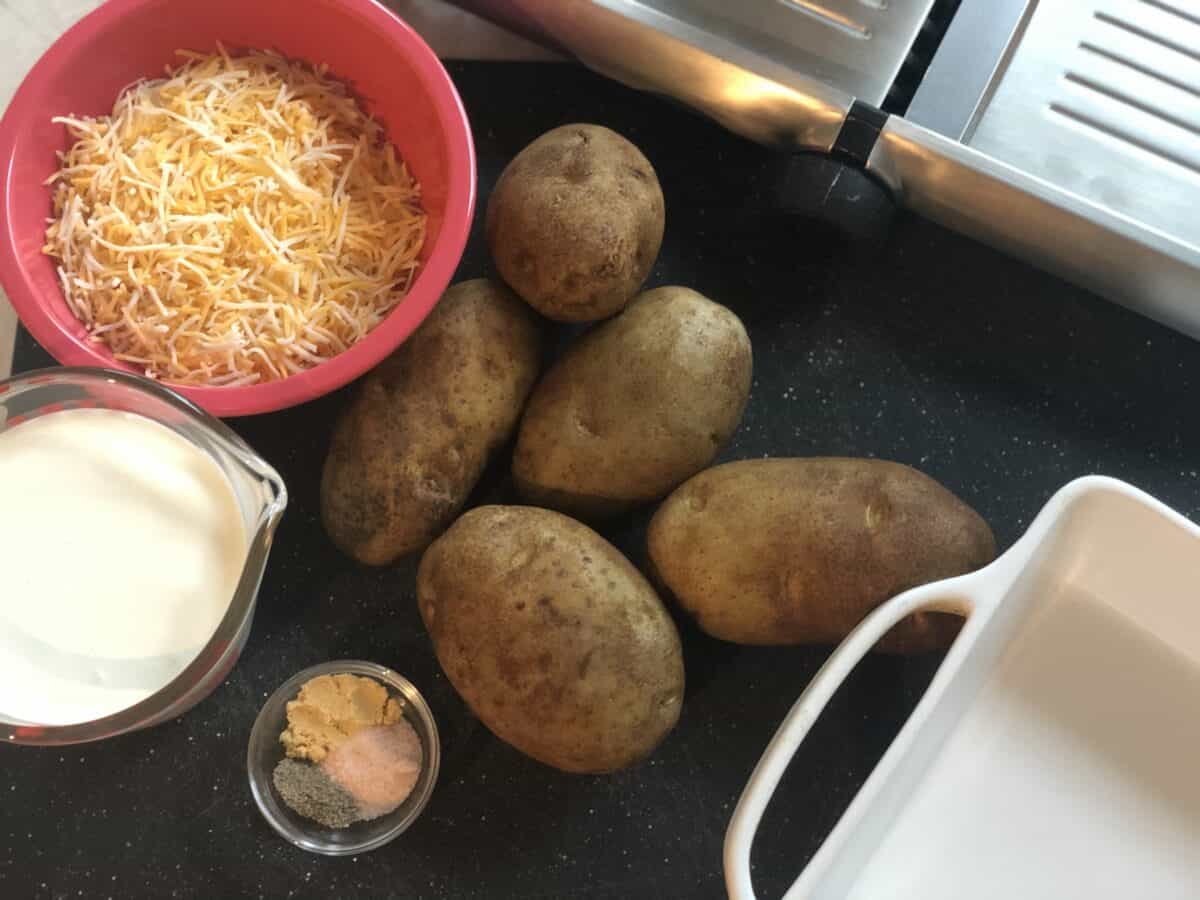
<box><xmin>0</xmin><ymin>409</ymin><xmax>247</xmax><ymax>725</ymax></box>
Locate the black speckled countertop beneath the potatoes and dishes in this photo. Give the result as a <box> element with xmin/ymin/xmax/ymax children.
<box><xmin>0</xmin><ymin>64</ymin><xmax>1200</xmax><ymax>900</ymax></box>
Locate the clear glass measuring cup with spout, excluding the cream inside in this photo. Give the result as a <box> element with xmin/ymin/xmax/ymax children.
<box><xmin>0</xmin><ymin>368</ymin><xmax>288</xmax><ymax>745</ymax></box>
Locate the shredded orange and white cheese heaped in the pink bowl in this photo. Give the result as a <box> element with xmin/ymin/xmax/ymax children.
<box><xmin>44</xmin><ymin>48</ymin><xmax>426</xmax><ymax>385</ymax></box>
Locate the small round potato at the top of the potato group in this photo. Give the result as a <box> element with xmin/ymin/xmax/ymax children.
<box><xmin>485</xmin><ymin>125</ymin><xmax>666</xmax><ymax>322</ymax></box>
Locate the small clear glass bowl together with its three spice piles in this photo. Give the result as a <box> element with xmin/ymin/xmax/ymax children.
<box><xmin>247</xmin><ymin>661</ymin><xmax>439</xmax><ymax>856</ymax></box>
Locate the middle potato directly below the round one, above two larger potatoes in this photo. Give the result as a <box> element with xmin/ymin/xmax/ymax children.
<box><xmin>512</xmin><ymin>287</ymin><xmax>752</xmax><ymax>518</ymax></box>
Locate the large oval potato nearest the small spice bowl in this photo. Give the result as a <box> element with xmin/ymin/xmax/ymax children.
<box><xmin>416</xmin><ymin>506</ymin><xmax>684</xmax><ymax>773</ymax></box>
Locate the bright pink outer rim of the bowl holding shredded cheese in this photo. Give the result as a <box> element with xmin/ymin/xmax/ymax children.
<box><xmin>0</xmin><ymin>0</ymin><xmax>476</xmax><ymax>416</ymax></box>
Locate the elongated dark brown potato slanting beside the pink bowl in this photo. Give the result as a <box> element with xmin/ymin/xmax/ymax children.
<box><xmin>320</xmin><ymin>278</ymin><xmax>541</xmax><ymax>565</ymax></box>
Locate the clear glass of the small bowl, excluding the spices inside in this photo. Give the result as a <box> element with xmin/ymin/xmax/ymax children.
<box><xmin>246</xmin><ymin>660</ymin><xmax>442</xmax><ymax>857</ymax></box>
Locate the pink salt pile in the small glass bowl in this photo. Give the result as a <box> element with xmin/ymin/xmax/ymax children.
<box><xmin>320</xmin><ymin>719</ymin><xmax>422</xmax><ymax>818</ymax></box>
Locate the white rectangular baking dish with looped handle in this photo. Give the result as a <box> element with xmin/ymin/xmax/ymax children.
<box><xmin>725</xmin><ymin>478</ymin><xmax>1200</xmax><ymax>900</ymax></box>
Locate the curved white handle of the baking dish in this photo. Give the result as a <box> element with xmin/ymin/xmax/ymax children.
<box><xmin>725</xmin><ymin>584</ymin><xmax>962</xmax><ymax>900</ymax></box>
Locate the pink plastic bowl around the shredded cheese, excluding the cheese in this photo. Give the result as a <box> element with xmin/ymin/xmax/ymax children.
<box><xmin>0</xmin><ymin>0</ymin><xmax>475</xmax><ymax>415</ymax></box>
